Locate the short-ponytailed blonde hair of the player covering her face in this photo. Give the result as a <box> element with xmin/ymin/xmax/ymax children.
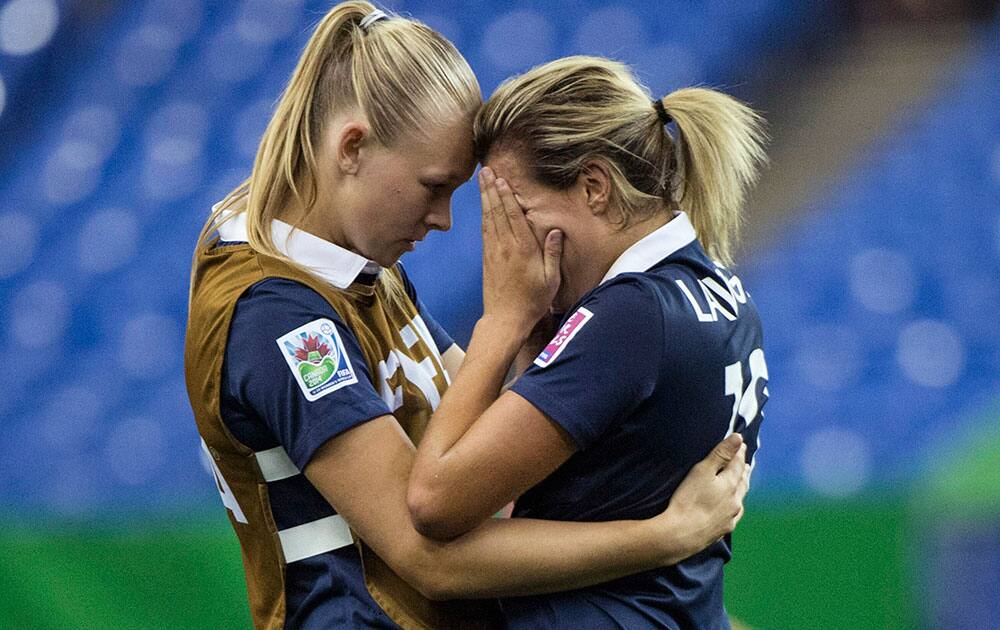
<box><xmin>474</xmin><ymin>56</ymin><xmax>766</xmax><ymax>264</ymax></box>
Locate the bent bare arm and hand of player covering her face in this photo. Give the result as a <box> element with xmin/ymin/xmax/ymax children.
<box><xmin>407</xmin><ymin>169</ymin><xmax>576</xmax><ymax>539</ymax></box>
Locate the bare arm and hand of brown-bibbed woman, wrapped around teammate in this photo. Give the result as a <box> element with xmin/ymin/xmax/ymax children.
<box><xmin>305</xmin><ymin>416</ymin><xmax>746</xmax><ymax>599</ymax></box>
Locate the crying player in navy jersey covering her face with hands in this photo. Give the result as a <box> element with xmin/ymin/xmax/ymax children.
<box><xmin>408</xmin><ymin>57</ymin><xmax>767</xmax><ymax>629</ymax></box>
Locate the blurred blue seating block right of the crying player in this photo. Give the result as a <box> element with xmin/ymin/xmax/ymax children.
<box><xmin>743</xmin><ymin>16</ymin><xmax>1000</xmax><ymax>495</ymax></box>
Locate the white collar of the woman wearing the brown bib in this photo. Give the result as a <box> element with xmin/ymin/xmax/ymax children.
<box><xmin>218</xmin><ymin>206</ymin><xmax>382</xmax><ymax>289</ymax></box>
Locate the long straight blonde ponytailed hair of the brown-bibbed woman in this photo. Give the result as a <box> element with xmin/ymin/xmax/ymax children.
<box><xmin>198</xmin><ymin>2</ymin><xmax>482</xmax><ymax>295</ymax></box>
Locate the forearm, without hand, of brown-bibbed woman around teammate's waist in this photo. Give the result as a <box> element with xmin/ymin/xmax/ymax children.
<box><xmin>421</xmin><ymin>518</ymin><xmax>696</xmax><ymax>599</ymax></box>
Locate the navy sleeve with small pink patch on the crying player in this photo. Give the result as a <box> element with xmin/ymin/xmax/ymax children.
<box><xmin>511</xmin><ymin>280</ymin><xmax>663</xmax><ymax>449</ymax></box>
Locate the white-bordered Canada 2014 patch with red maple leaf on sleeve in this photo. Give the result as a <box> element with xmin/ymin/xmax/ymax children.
<box><xmin>275</xmin><ymin>319</ymin><xmax>358</xmax><ymax>402</ymax></box>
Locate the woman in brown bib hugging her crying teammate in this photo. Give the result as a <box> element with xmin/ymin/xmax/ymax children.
<box><xmin>185</xmin><ymin>2</ymin><xmax>745</xmax><ymax>628</ymax></box>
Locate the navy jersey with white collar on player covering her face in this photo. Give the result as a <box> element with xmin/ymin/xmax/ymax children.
<box><xmin>503</xmin><ymin>214</ymin><xmax>767</xmax><ymax>628</ymax></box>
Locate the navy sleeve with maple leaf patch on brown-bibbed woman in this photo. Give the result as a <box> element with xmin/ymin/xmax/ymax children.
<box><xmin>222</xmin><ymin>278</ymin><xmax>391</xmax><ymax>470</ymax></box>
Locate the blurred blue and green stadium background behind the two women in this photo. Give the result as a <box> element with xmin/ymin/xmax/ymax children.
<box><xmin>0</xmin><ymin>0</ymin><xmax>1000</xmax><ymax>629</ymax></box>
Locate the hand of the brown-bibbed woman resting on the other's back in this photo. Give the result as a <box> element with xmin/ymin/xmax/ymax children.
<box><xmin>653</xmin><ymin>433</ymin><xmax>750</xmax><ymax>564</ymax></box>
